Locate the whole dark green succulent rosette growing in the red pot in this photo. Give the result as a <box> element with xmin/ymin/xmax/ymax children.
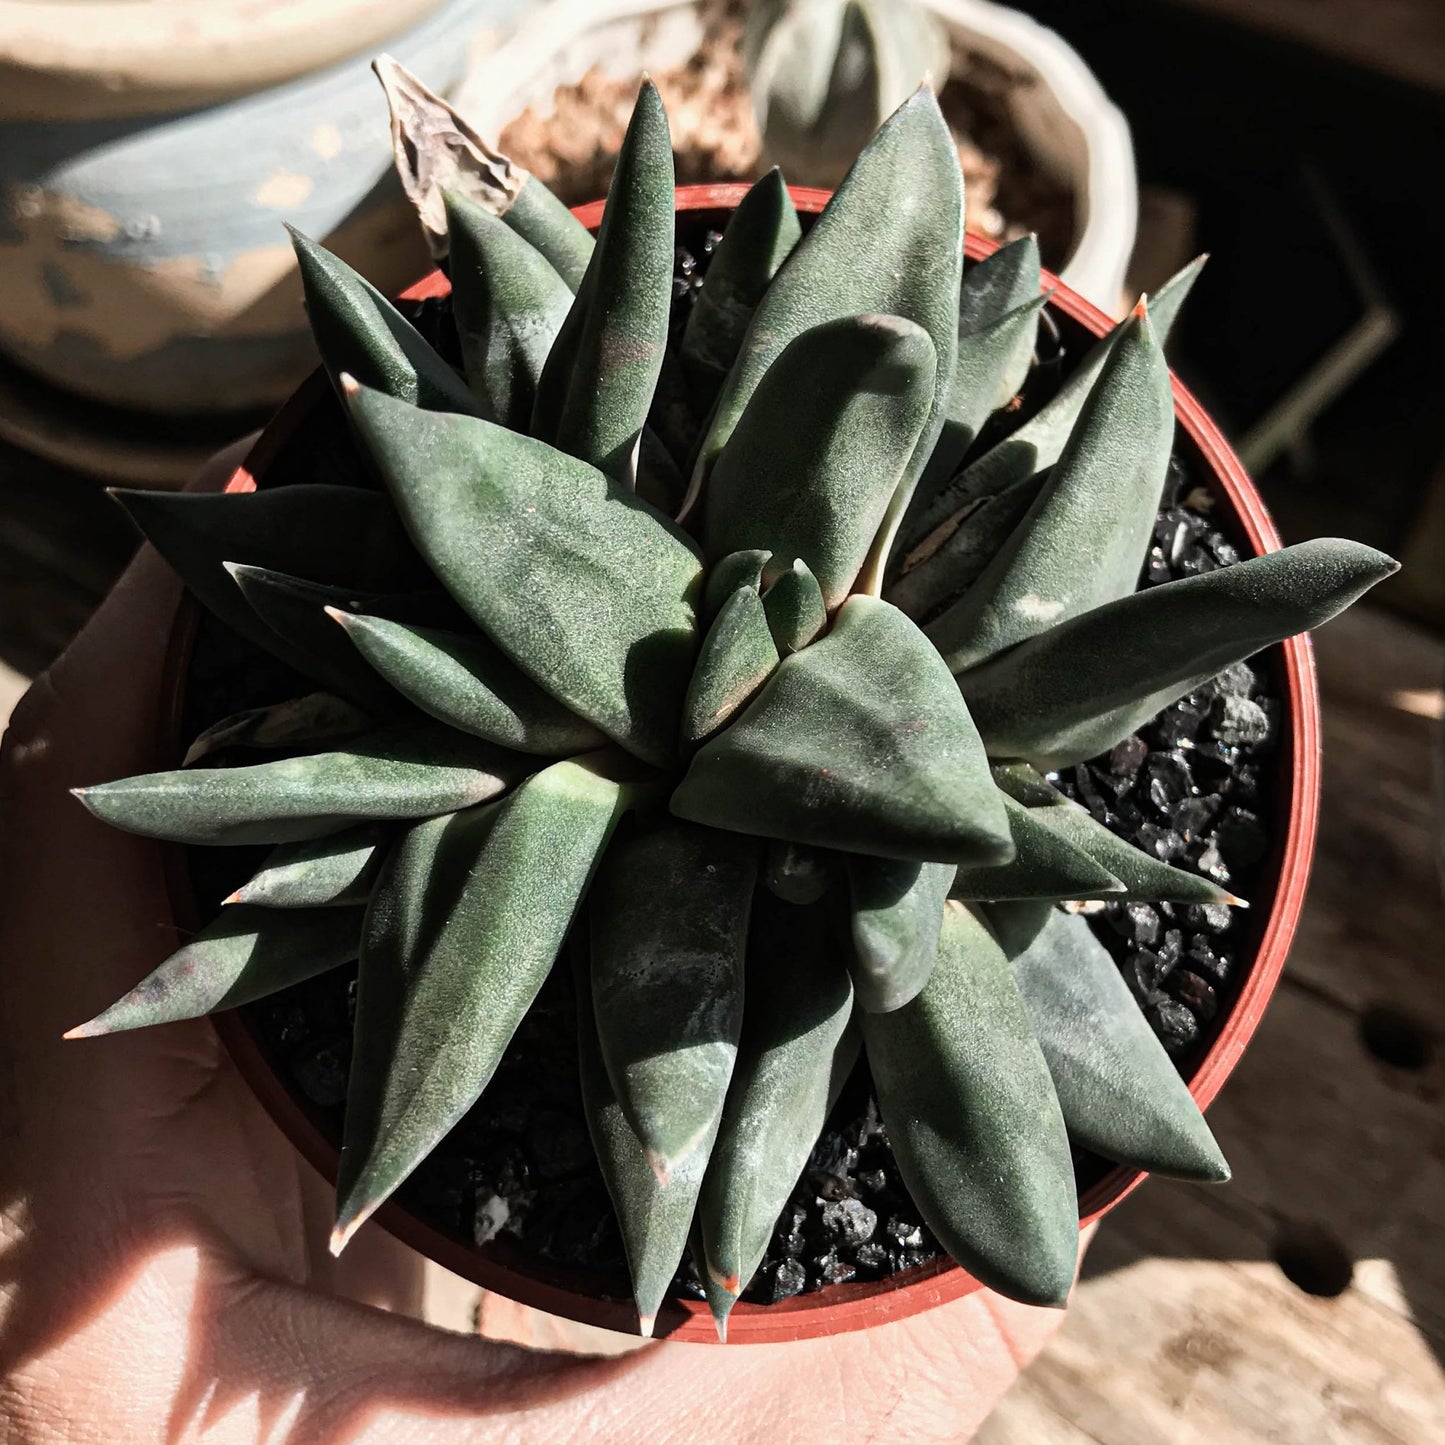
<box><xmin>72</xmin><ymin>68</ymin><xmax>1394</xmax><ymax>1332</ymax></box>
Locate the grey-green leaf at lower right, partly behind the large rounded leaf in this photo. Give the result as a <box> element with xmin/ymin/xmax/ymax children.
<box><xmin>988</xmin><ymin>903</ymin><xmax>1230</xmax><ymax>1183</ymax></box>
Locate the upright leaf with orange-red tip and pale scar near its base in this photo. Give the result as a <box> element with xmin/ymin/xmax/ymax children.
<box><xmin>926</xmin><ymin>311</ymin><xmax>1175</xmax><ymax>672</ymax></box>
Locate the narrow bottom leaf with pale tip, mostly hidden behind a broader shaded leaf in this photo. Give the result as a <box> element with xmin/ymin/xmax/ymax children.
<box><xmin>571</xmin><ymin>948</ymin><xmax>715</xmax><ymax>1335</ymax></box>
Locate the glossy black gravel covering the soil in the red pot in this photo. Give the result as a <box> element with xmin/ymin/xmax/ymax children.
<box><xmin>174</xmin><ymin>218</ymin><xmax>1280</xmax><ymax>1302</ymax></box>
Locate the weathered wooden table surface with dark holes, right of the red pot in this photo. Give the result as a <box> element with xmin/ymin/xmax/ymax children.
<box><xmin>980</xmin><ymin>608</ymin><xmax>1445</xmax><ymax>1445</ymax></box>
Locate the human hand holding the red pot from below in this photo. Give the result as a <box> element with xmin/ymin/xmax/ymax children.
<box><xmin>0</xmin><ymin>442</ymin><xmax>1086</xmax><ymax>1445</ymax></box>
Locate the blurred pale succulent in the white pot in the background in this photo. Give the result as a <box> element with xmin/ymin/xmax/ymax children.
<box><xmin>743</xmin><ymin>0</ymin><xmax>951</xmax><ymax>186</ymax></box>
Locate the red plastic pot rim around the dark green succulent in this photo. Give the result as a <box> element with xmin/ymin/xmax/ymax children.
<box><xmin>165</xmin><ymin>185</ymin><xmax>1319</xmax><ymax>1344</ymax></box>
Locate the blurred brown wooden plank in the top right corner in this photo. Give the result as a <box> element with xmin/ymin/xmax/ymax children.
<box><xmin>1175</xmin><ymin>0</ymin><xmax>1445</xmax><ymax>91</ymax></box>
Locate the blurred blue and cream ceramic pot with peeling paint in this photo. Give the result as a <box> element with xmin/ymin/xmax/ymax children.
<box><xmin>0</xmin><ymin>0</ymin><xmax>522</xmax><ymax>415</ymax></box>
